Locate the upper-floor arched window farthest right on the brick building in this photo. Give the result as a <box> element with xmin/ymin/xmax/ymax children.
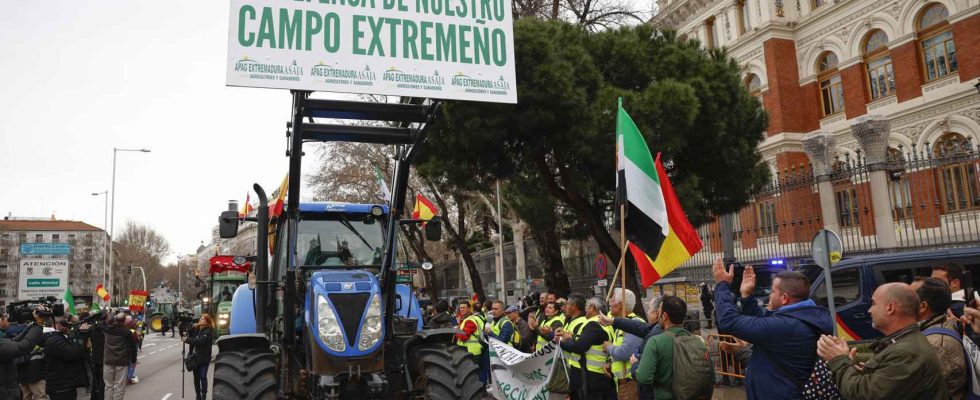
<box><xmin>916</xmin><ymin>3</ymin><xmax>959</xmax><ymax>81</ymax></box>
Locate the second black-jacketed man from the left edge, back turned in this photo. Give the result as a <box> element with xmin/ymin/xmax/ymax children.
<box><xmin>44</xmin><ymin>318</ymin><xmax>88</xmax><ymax>400</ymax></box>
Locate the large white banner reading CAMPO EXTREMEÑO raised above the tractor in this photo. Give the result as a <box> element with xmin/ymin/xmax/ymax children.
<box><xmin>226</xmin><ymin>0</ymin><xmax>517</xmax><ymax>103</ymax></box>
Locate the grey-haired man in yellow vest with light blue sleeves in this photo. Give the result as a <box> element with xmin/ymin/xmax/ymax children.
<box><xmin>602</xmin><ymin>288</ymin><xmax>643</xmax><ymax>400</ymax></box>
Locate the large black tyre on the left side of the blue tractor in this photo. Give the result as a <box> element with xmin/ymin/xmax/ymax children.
<box><xmin>212</xmin><ymin>348</ymin><xmax>276</xmax><ymax>400</ymax></box>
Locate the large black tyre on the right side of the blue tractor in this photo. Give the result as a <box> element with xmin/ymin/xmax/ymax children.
<box><xmin>413</xmin><ymin>342</ymin><xmax>486</xmax><ymax>400</ymax></box>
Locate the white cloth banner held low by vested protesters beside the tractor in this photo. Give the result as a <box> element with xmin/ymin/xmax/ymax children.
<box><xmin>489</xmin><ymin>338</ymin><xmax>563</xmax><ymax>400</ymax></box>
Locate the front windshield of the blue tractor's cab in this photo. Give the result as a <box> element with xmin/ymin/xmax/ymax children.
<box><xmin>296</xmin><ymin>213</ymin><xmax>384</xmax><ymax>266</ymax></box>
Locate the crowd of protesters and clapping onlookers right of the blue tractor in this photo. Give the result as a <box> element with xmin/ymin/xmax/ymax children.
<box><xmin>428</xmin><ymin>259</ymin><xmax>980</xmax><ymax>400</ymax></box>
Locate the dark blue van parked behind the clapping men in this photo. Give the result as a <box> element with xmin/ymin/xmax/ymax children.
<box><xmin>810</xmin><ymin>247</ymin><xmax>980</xmax><ymax>340</ymax></box>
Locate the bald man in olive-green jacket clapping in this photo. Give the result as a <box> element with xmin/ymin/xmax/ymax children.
<box><xmin>817</xmin><ymin>283</ymin><xmax>946</xmax><ymax>400</ymax></box>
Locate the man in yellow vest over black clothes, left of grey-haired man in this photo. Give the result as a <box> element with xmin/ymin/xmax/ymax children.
<box><xmin>556</xmin><ymin>294</ymin><xmax>616</xmax><ymax>400</ymax></box>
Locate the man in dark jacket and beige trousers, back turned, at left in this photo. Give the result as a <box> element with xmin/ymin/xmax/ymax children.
<box><xmin>102</xmin><ymin>313</ymin><xmax>137</xmax><ymax>400</ymax></box>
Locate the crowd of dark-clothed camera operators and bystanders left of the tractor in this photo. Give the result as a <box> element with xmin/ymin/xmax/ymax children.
<box><xmin>0</xmin><ymin>307</ymin><xmax>214</xmax><ymax>400</ymax></box>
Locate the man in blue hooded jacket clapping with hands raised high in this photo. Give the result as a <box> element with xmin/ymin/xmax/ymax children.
<box><xmin>712</xmin><ymin>257</ymin><xmax>834</xmax><ymax>400</ymax></box>
